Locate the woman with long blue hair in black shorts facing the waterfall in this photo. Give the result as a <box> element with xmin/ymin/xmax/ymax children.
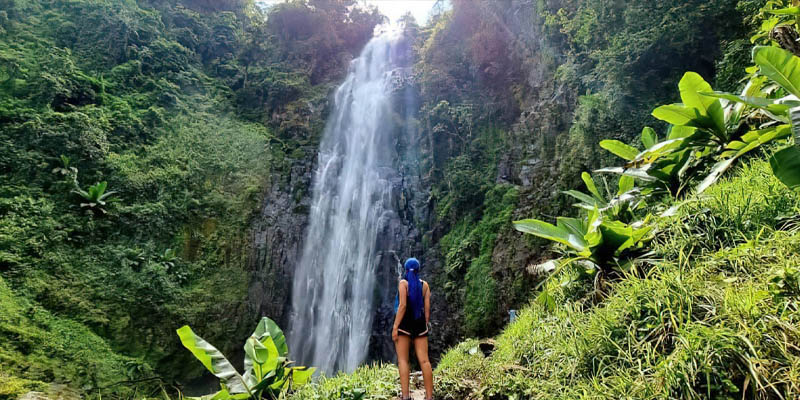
<box><xmin>392</xmin><ymin>258</ymin><xmax>433</xmax><ymax>400</ymax></box>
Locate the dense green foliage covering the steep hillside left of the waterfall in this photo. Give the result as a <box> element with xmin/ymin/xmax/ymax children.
<box><xmin>0</xmin><ymin>0</ymin><xmax>366</xmax><ymax>396</ymax></box>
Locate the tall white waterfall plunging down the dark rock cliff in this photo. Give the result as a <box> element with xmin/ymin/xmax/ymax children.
<box><xmin>289</xmin><ymin>26</ymin><xmax>410</xmax><ymax>373</ymax></box>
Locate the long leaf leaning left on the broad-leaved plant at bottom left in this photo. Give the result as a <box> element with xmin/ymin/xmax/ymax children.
<box><xmin>177</xmin><ymin>325</ymin><xmax>248</xmax><ymax>393</ymax></box>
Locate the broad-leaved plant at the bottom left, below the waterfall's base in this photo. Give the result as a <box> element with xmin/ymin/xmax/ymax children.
<box><xmin>177</xmin><ymin>317</ymin><xmax>315</xmax><ymax>400</ymax></box>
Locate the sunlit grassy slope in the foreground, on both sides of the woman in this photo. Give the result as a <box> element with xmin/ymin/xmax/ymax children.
<box><xmin>297</xmin><ymin>155</ymin><xmax>800</xmax><ymax>399</ymax></box>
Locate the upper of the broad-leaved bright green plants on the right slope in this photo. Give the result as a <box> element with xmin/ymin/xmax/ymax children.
<box><xmin>597</xmin><ymin>70</ymin><xmax>797</xmax><ymax>196</ymax></box>
